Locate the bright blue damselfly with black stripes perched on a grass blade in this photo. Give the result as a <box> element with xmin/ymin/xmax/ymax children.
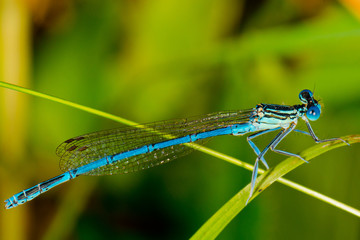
<box><xmin>5</xmin><ymin>90</ymin><xmax>343</xmax><ymax>209</ymax></box>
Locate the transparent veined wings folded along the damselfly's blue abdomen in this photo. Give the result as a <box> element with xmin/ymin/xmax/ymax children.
<box><xmin>56</xmin><ymin>109</ymin><xmax>253</xmax><ymax>175</ymax></box>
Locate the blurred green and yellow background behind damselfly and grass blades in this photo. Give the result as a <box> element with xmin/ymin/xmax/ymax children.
<box><xmin>0</xmin><ymin>0</ymin><xmax>360</xmax><ymax>239</ymax></box>
